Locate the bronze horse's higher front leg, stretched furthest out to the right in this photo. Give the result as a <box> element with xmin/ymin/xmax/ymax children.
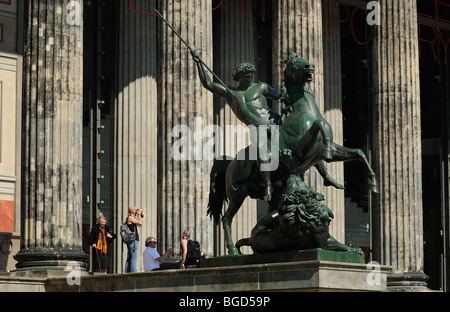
<box><xmin>326</xmin><ymin>143</ymin><xmax>380</xmax><ymax>193</ymax></box>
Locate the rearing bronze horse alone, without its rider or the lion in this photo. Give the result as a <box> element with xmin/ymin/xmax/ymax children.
<box><xmin>208</xmin><ymin>53</ymin><xmax>378</xmax><ymax>254</ymax></box>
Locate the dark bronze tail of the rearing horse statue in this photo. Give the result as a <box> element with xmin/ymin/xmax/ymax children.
<box><xmin>207</xmin><ymin>157</ymin><xmax>231</xmax><ymax>225</ymax></box>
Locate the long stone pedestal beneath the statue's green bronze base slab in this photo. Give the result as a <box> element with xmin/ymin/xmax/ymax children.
<box><xmin>41</xmin><ymin>252</ymin><xmax>390</xmax><ymax>296</ymax></box>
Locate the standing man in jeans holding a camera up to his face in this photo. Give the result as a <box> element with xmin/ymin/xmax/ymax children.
<box><xmin>125</xmin><ymin>206</ymin><xmax>144</xmax><ymax>273</ymax></box>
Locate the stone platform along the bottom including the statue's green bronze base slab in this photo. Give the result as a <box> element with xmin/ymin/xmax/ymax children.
<box><xmin>0</xmin><ymin>249</ymin><xmax>390</xmax><ymax>292</ymax></box>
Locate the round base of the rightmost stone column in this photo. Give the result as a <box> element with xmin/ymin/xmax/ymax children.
<box><xmin>387</xmin><ymin>271</ymin><xmax>429</xmax><ymax>291</ymax></box>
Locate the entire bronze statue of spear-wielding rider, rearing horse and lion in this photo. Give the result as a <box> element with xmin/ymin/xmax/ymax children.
<box><xmin>155</xmin><ymin>10</ymin><xmax>372</xmax><ymax>254</ymax></box>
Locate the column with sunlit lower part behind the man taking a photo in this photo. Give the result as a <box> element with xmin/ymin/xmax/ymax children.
<box><xmin>114</xmin><ymin>0</ymin><xmax>158</xmax><ymax>272</ymax></box>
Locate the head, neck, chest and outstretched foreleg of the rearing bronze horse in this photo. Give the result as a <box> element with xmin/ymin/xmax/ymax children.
<box><xmin>280</xmin><ymin>53</ymin><xmax>378</xmax><ymax>193</ymax></box>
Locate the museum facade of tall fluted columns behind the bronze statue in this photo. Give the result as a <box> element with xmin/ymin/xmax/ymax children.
<box><xmin>0</xmin><ymin>0</ymin><xmax>450</xmax><ymax>290</ymax></box>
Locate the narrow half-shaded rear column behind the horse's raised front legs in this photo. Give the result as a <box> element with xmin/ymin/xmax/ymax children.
<box><xmin>323</xmin><ymin>1</ymin><xmax>345</xmax><ymax>243</ymax></box>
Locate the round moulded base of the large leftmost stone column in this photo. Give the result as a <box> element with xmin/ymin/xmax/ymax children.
<box><xmin>14</xmin><ymin>248</ymin><xmax>88</xmax><ymax>271</ymax></box>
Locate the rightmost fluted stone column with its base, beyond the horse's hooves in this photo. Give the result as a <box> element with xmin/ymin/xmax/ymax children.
<box><xmin>373</xmin><ymin>0</ymin><xmax>427</xmax><ymax>289</ymax></box>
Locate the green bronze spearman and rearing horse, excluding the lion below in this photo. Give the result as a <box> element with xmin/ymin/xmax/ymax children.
<box><xmin>193</xmin><ymin>53</ymin><xmax>378</xmax><ymax>254</ymax></box>
